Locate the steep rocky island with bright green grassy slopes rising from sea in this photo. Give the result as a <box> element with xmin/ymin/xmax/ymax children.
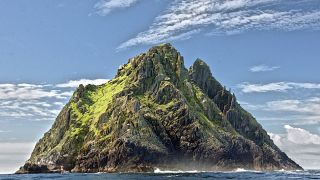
<box><xmin>17</xmin><ymin>44</ymin><xmax>301</xmax><ymax>173</ymax></box>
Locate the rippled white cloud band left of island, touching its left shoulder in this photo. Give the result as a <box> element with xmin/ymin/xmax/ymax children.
<box><xmin>0</xmin><ymin>79</ymin><xmax>108</xmax><ymax>121</ymax></box>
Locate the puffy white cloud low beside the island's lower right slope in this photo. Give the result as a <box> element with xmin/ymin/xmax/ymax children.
<box><xmin>269</xmin><ymin>125</ymin><xmax>320</xmax><ymax>169</ymax></box>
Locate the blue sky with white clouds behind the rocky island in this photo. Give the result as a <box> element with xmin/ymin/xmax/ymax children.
<box><xmin>0</xmin><ymin>0</ymin><xmax>320</xmax><ymax>173</ymax></box>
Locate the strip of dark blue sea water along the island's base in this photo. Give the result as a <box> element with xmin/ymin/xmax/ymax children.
<box><xmin>0</xmin><ymin>170</ymin><xmax>320</xmax><ymax>180</ymax></box>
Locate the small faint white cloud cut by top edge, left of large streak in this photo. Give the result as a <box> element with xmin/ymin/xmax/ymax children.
<box><xmin>95</xmin><ymin>0</ymin><xmax>139</xmax><ymax>15</ymax></box>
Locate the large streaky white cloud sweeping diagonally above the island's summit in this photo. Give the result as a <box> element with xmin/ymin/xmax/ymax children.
<box><xmin>119</xmin><ymin>0</ymin><xmax>320</xmax><ymax>49</ymax></box>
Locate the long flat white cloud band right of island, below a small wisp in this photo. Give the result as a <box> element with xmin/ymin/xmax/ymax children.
<box><xmin>238</xmin><ymin>82</ymin><xmax>320</xmax><ymax>93</ymax></box>
